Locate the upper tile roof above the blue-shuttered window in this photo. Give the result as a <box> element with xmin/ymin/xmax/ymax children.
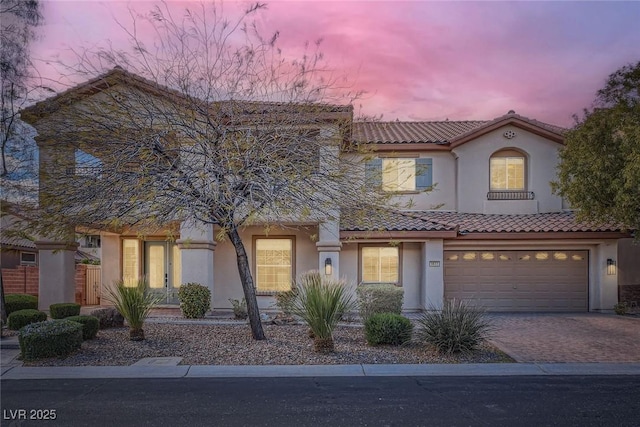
<box><xmin>353</xmin><ymin>121</ymin><xmax>487</xmax><ymax>144</ymax></box>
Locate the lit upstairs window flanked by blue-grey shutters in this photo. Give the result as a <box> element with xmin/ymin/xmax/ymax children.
<box><xmin>365</xmin><ymin>157</ymin><xmax>433</xmax><ymax>192</ymax></box>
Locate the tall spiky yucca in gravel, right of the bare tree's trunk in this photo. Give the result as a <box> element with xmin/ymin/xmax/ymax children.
<box><xmin>291</xmin><ymin>271</ymin><xmax>353</xmax><ymax>353</ymax></box>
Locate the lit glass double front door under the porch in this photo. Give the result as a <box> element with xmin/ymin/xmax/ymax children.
<box><xmin>144</xmin><ymin>241</ymin><xmax>180</xmax><ymax>304</ymax></box>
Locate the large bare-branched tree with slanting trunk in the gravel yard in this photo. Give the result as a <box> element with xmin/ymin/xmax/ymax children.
<box><xmin>24</xmin><ymin>0</ymin><xmax>408</xmax><ymax>339</ymax></box>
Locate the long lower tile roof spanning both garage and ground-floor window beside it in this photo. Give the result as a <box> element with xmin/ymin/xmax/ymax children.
<box><xmin>340</xmin><ymin>211</ymin><xmax>622</xmax><ymax>235</ymax></box>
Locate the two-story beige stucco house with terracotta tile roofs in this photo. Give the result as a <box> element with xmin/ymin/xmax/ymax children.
<box><xmin>17</xmin><ymin>68</ymin><xmax>640</xmax><ymax>311</ymax></box>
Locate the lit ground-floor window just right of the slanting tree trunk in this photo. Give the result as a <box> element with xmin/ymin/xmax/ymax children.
<box><xmin>254</xmin><ymin>237</ymin><xmax>294</xmax><ymax>293</ymax></box>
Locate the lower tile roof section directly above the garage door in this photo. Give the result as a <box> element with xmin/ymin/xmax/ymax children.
<box><xmin>412</xmin><ymin>211</ymin><xmax>621</xmax><ymax>234</ymax></box>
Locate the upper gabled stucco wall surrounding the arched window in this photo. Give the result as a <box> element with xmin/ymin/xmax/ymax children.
<box><xmin>453</xmin><ymin>125</ymin><xmax>562</xmax><ymax>213</ymax></box>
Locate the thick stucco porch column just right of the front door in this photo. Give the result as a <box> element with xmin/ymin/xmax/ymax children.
<box><xmin>176</xmin><ymin>221</ymin><xmax>216</xmax><ymax>307</ymax></box>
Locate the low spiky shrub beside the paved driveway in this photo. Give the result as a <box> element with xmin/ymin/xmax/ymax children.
<box><xmin>416</xmin><ymin>300</ymin><xmax>492</xmax><ymax>354</ymax></box>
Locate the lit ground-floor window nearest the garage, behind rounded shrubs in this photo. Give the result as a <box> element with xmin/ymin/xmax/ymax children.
<box><xmin>360</xmin><ymin>246</ymin><xmax>400</xmax><ymax>283</ymax></box>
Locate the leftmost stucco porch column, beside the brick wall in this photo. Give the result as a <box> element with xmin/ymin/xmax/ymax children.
<box><xmin>36</xmin><ymin>240</ymin><xmax>78</xmax><ymax>311</ymax></box>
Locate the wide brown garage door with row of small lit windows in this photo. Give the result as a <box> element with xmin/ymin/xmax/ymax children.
<box><xmin>444</xmin><ymin>250</ymin><xmax>589</xmax><ymax>311</ymax></box>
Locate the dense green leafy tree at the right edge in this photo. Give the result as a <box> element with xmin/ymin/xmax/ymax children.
<box><xmin>552</xmin><ymin>62</ymin><xmax>640</xmax><ymax>237</ymax></box>
